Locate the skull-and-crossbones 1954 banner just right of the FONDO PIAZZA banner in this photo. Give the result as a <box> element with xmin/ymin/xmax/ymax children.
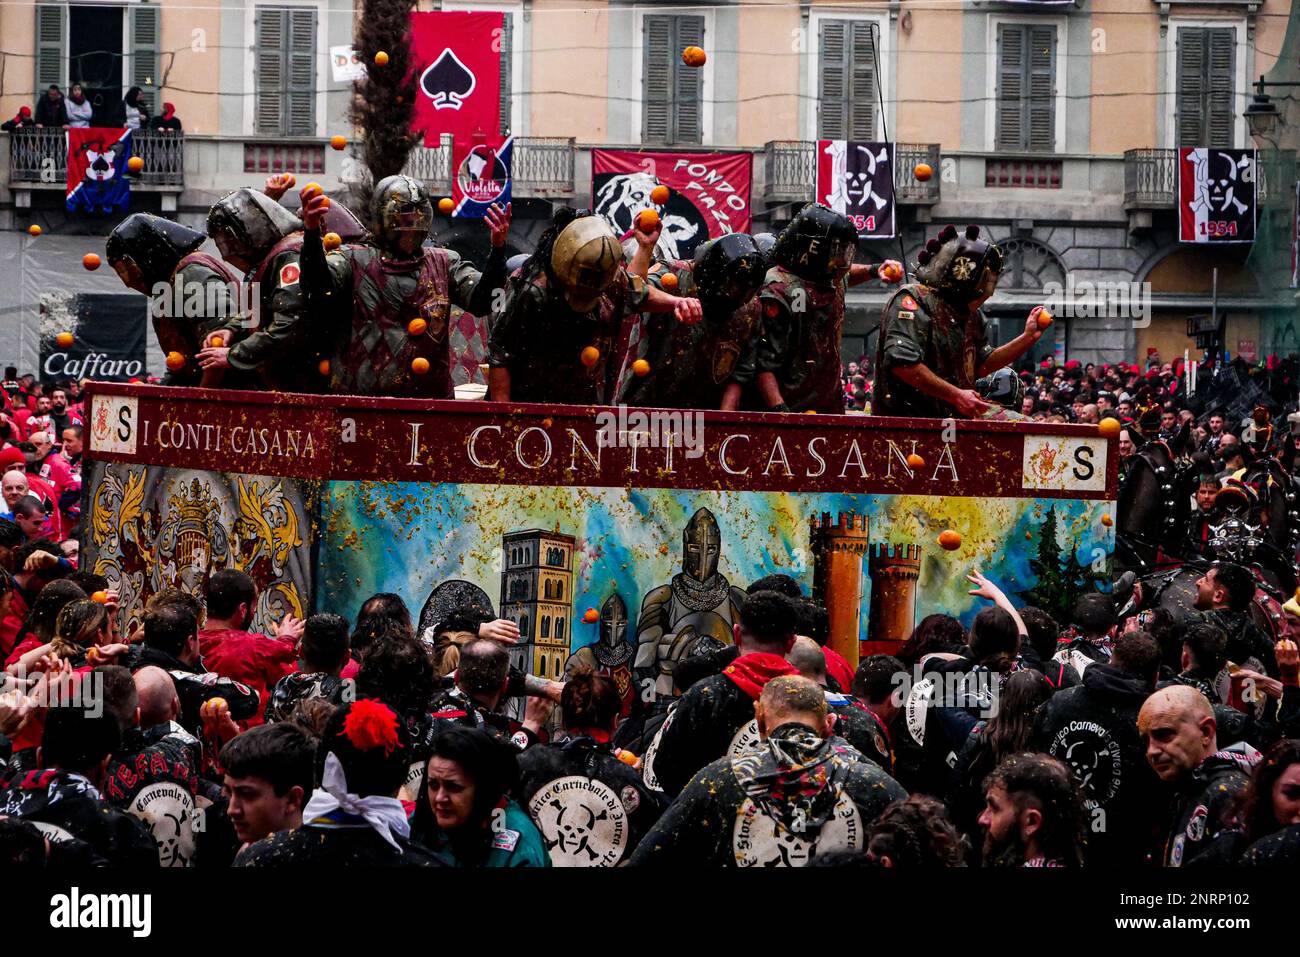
<box><xmin>816</xmin><ymin>139</ymin><xmax>894</xmax><ymax>239</ymax></box>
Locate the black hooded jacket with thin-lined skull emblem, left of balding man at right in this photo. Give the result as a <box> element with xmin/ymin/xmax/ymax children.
<box><xmin>1029</xmin><ymin>662</ymin><xmax>1160</xmax><ymax>865</ymax></box>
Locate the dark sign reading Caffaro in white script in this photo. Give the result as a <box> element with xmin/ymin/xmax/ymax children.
<box><xmin>40</xmin><ymin>293</ymin><xmax>148</xmax><ymax>384</ymax></box>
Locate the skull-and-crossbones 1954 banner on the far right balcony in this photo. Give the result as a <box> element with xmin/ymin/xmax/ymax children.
<box><xmin>1178</xmin><ymin>147</ymin><xmax>1258</xmax><ymax>243</ymax></box>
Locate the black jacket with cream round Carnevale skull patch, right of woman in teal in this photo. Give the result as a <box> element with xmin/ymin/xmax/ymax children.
<box><xmin>519</xmin><ymin>735</ymin><xmax>663</xmax><ymax>867</ymax></box>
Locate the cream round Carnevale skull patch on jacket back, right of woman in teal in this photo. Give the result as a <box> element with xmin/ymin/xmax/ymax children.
<box><xmin>528</xmin><ymin>774</ymin><xmax>628</xmax><ymax>867</ymax></box>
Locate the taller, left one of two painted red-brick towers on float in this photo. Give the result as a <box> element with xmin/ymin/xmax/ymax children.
<box><xmin>809</xmin><ymin>512</ymin><xmax>867</xmax><ymax>667</ymax></box>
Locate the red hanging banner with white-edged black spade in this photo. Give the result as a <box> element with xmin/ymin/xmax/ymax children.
<box><xmin>411</xmin><ymin>10</ymin><xmax>506</xmax><ymax>150</ymax></box>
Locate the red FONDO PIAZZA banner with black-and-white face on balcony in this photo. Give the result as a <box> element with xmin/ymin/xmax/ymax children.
<box><xmin>592</xmin><ymin>150</ymin><xmax>754</xmax><ymax>259</ymax></box>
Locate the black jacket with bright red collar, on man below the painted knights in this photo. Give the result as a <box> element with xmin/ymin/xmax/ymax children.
<box><xmin>654</xmin><ymin>653</ymin><xmax>798</xmax><ymax>797</ymax></box>
